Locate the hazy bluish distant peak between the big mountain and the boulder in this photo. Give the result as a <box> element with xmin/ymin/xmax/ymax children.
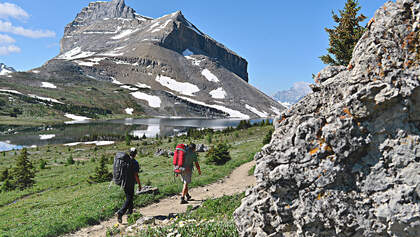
<box><xmin>273</xmin><ymin>81</ymin><xmax>312</xmax><ymax>107</ymax></box>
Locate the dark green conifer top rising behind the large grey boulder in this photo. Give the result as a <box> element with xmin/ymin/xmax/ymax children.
<box><xmin>319</xmin><ymin>0</ymin><xmax>366</xmax><ymax>66</ymax></box>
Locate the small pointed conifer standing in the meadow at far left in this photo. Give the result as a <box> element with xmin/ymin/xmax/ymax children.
<box><xmin>12</xmin><ymin>148</ymin><xmax>35</xmax><ymax>190</ymax></box>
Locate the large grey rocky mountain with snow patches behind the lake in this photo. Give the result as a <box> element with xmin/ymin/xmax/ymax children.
<box><xmin>31</xmin><ymin>0</ymin><xmax>284</xmax><ymax>118</ymax></box>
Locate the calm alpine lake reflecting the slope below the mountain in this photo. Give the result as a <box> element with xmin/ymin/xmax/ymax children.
<box><xmin>0</xmin><ymin>118</ymin><xmax>265</xmax><ymax>151</ymax></box>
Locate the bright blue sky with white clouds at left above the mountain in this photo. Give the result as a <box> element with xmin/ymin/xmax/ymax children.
<box><xmin>0</xmin><ymin>0</ymin><xmax>386</xmax><ymax>95</ymax></box>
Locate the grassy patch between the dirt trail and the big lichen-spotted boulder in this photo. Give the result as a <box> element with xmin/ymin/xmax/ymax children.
<box><xmin>136</xmin><ymin>193</ymin><xmax>244</xmax><ymax>237</ymax></box>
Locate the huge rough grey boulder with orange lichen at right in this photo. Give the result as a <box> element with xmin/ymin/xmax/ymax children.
<box><xmin>234</xmin><ymin>0</ymin><xmax>420</xmax><ymax>236</ymax></box>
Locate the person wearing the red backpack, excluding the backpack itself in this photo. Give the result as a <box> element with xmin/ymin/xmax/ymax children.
<box><xmin>181</xmin><ymin>143</ymin><xmax>201</xmax><ymax>204</ymax></box>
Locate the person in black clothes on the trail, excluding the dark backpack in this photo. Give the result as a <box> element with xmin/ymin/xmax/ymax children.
<box><xmin>117</xmin><ymin>147</ymin><xmax>141</xmax><ymax>223</ymax></box>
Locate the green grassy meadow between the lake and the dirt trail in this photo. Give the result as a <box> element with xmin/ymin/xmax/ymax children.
<box><xmin>0</xmin><ymin>126</ymin><xmax>270</xmax><ymax>236</ymax></box>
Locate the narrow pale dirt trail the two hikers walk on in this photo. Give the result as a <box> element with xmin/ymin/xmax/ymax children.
<box><xmin>64</xmin><ymin>161</ymin><xmax>255</xmax><ymax>237</ymax></box>
